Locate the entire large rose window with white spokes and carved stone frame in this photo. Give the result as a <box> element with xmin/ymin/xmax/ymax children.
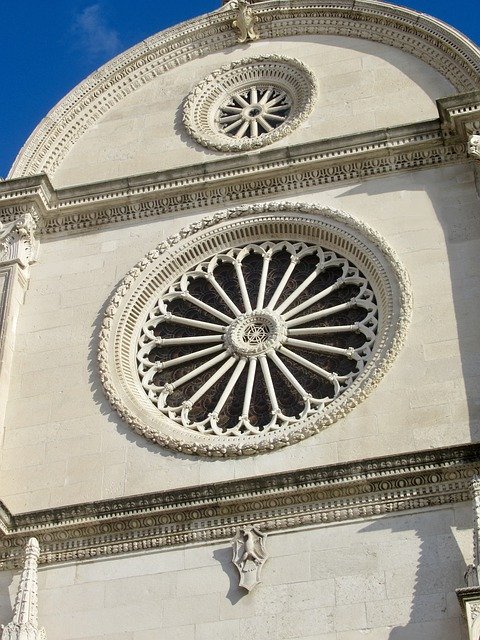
<box><xmin>99</xmin><ymin>203</ymin><xmax>412</xmax><ymax>456</ymax></box>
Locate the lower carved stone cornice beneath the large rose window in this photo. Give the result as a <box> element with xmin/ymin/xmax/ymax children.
<box><xmin>0</xmin><ymin>444</ymin><xmax>480</xmax><ymax>569</ymax></box>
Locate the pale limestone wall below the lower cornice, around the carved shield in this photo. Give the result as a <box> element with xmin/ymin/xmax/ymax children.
<box><xmin>0</xmin><ymin>504</ymin><xmax>471</xmax><ymax>640</ymax></box>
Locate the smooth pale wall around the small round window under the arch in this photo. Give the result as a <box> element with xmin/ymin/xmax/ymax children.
<box><xmin>53</xmin><ymin>35</ymin><xmax>456</xmax><ymax>187</ymax></box>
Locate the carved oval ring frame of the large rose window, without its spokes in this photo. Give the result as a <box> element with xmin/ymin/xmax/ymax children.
<box><xmin>98</xmin><ymin>202</ymin><xmax>412</xmax><ymax>457</ymax></box>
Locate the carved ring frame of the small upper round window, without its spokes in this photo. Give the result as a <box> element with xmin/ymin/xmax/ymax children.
<box><xmin>183</xmin><ymin>55</ymin><xmax>317</xmax><ymax>151</ymax></box>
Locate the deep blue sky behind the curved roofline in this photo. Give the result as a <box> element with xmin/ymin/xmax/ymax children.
<box><xmin>0</xmin><ymin>0</ymin><xmax>480</xmax><ymax>176</ymax></box>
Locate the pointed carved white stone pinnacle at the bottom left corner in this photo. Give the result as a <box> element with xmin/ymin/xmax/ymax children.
<box><xmin>1</xmin><ymin>538</ymin><xmax>46</xmax><ymax>640</ymax></box>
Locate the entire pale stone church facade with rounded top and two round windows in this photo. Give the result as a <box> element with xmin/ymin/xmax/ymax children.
<box><xmin>0</xmin><ymin>0</ymin><xmax>480</xmax><ymax>640</ymax></box>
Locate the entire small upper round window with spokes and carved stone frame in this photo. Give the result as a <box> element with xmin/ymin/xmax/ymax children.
<box><xmin>183</xmin><ymin>55</ymin><xmax>317</xmax><ymax>151</ymax></box>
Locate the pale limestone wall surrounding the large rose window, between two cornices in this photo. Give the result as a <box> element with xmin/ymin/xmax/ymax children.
<box><xmin>0</xmin><ymin>166</ymin><xmax>480</xmax><ymax>512</ymax></box>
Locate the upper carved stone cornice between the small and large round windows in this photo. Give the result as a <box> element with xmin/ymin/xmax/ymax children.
<box><xmin>0</xmin><ymin>119</ymin><xmax>468</xmax><ymax>235</ymax></box>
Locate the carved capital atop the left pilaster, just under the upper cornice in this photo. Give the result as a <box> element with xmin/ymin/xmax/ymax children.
<box><xmin>0</xmin><ymin>213</ymin><xmax>38</xmax><ymax>268</ymax></box>
